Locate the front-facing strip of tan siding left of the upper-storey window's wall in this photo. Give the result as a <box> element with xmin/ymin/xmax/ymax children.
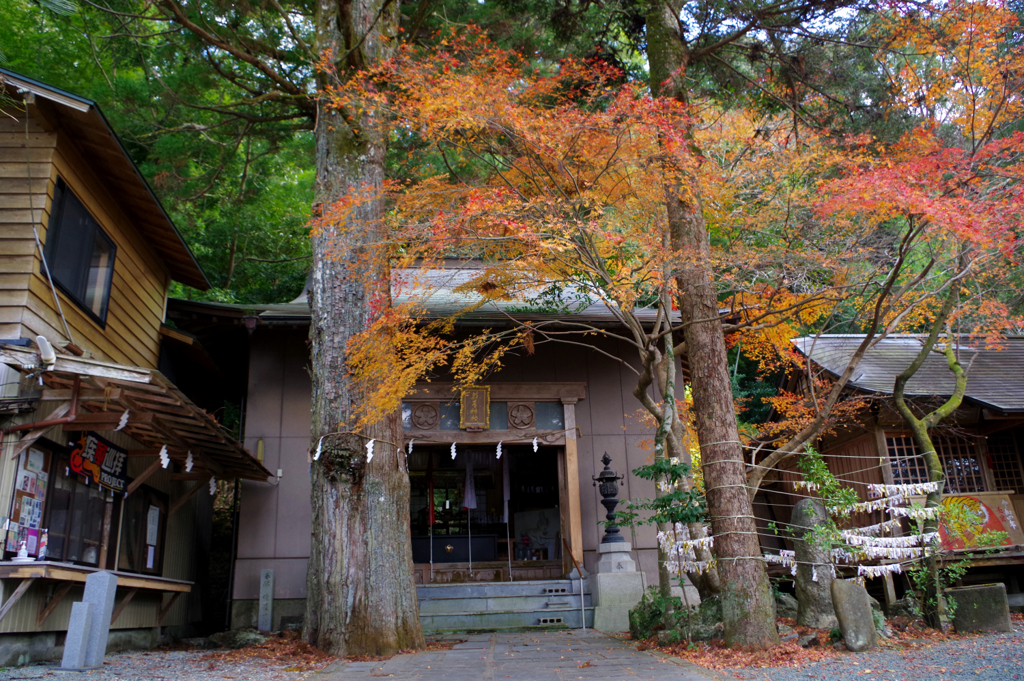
<box><xmin>0</xmin><ymin>116</ymin><xmax>57</xmax><ymax>338</ymax></box>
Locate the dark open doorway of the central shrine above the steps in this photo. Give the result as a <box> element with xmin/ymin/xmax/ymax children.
<box><xmin>409</xmin><ymin>442</ymin><xmax>568</xmax><ymax>584</ymax></box>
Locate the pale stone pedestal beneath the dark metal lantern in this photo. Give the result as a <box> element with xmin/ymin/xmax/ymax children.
<box><xmin>591</xmin><ymin>542</ymin><xmax>643</xmax><ymax>632</ymax></box>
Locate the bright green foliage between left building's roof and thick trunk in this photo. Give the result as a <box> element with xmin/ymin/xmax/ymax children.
<box><xmin>0</xmin><ymin>0</ymin><xmax>314</xmax><ymax>303</ymax></box>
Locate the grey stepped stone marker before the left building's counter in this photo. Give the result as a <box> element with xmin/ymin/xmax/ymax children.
<box><xmin>60</xmin><ymin>570</ymin><xmax>118</xmax><ymax>669</ymax></box>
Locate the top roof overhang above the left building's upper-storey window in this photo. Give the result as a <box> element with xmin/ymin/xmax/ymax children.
<box><xmin>0</xmin><ymin>69</ymin><xmax>210</xmax><ymax>291</ymax></box>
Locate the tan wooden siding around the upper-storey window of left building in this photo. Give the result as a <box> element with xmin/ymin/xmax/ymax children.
<box><xmin>0</xmin><ymin>112</ymin><xmax>170</xmax><ymax>368</ymax></box>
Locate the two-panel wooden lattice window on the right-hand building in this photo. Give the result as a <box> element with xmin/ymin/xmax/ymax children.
<box><xmin>886</xmin><ymin>435</ymin><xmax>985</xmax><ymax>494</ymax></box>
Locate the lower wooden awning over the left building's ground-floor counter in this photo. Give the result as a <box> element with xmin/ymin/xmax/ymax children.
<box><xmin>0</xmin><ymin>344</ymin><xmax>270</xmax><ymax>486</ymax></box>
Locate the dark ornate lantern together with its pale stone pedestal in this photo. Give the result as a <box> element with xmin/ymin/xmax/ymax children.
<box><xmin>593</xmin><ymin>453</ymin><xmax>643</xmax><ymax>632</ymax></box>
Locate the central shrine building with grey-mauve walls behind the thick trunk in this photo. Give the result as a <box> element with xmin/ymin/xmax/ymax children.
<box><xmin>168</xmin><ymin>263</ymin><xmax>696</xmax><ymax>629</ymax></box>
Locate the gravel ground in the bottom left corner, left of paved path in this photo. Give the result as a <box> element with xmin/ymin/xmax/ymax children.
<box><xmin>0</xmin><ymin>650</ymin><xmax>315</xmax><ymax>681</ymax></box>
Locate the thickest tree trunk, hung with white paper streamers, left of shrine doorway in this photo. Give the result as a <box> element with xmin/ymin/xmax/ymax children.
<box><xmin>304</xmin><ymin>0</ymin><xmax>423</xmax><ymax>655</ymax></box>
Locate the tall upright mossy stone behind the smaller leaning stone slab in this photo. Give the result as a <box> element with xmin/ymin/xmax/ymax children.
<box><xmin>790</xmin><ymin>499</ymin><xmax>836</xmax><ymax>629</ymax></box>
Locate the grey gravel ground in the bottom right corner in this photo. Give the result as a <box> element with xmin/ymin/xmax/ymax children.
<box><xmin>745</xmin><ymin>624</ymin><xmax>1024</xmax><ymax>681</ymax></box>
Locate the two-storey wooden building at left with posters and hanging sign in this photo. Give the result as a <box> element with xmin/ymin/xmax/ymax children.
<box><xmin>0</xmin><ymin>69</ymin><xmax>267</xmax><ymax>666</ymax></box>
